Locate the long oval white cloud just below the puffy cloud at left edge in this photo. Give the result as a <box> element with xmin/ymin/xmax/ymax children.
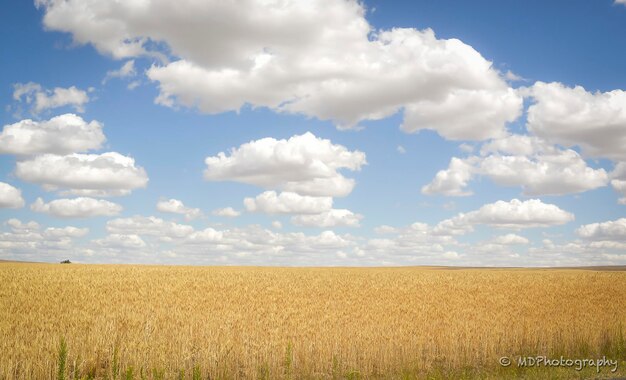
<box><xmin>15</xmin><ymin>152</ymin><xmax>148</xmax><ymax>195</ymax></box>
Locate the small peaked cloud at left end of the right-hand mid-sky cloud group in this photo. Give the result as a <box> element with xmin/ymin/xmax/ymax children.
<box><xmin>422</xmin><ymin>157</ymin><xmax>474</xmax><ymax>197</ymax></box>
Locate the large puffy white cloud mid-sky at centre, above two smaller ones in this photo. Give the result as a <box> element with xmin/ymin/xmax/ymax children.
<box><xmin>204</xmin><ymin>132</ymin><xmax>366</xmax><ymax>196</ymax></box>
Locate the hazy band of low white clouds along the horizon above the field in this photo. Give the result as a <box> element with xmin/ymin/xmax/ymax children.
<box><xmin>0</xmin><ymin>212</ymin><xmax>626</xmax><ymax>266</ymax></box>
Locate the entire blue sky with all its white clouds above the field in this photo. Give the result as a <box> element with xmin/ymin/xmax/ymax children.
<box><xmin>0</xmin><ymin>0</ymin><xmax>626</xmax><ymax>266</ymax></box>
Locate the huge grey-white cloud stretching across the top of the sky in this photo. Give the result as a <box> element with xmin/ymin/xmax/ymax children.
<box><xmin>37</xmin><ymin>0</ymin><xmax>522</xmax><ymax>139</ymax></box>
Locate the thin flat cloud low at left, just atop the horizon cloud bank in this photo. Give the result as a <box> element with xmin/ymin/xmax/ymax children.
<box><xmin>106</xmin><ymin>215</ymin><xmax>194</xmax><ymax>238</ymax></box>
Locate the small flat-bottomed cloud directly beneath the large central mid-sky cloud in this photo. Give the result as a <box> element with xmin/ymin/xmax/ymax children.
<box><xmin>243</xmin><ymin>191</ymin><xmax>333</xmax><ymax>214</ymax></box>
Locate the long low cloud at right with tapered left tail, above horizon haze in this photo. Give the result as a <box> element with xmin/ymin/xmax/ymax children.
<box><xmin>437</xmin><ymin>199</ymin><xmax>574</xmax><ymax>234</ymax></box>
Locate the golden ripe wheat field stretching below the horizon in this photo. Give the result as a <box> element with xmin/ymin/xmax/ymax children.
<box><xmin>0</xmin><ymin>263</ymin><xmax>626</xmax><ymax>379</ymax></box>
